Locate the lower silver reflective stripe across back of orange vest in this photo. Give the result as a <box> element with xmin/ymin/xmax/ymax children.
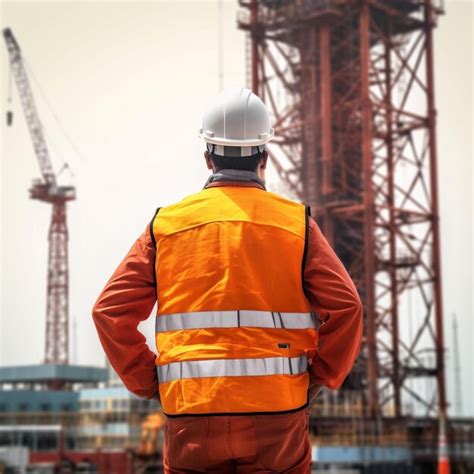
<box><xmin>156</xmin><ymin>355</ymin><xmax>308</xmax><ymax>383</ymax></box>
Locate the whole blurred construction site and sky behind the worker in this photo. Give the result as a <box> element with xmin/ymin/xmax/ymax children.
<box><xmin>0</xmin><ymin>0</ymin><xmax>474</xmax><ymax>474</ymax></box>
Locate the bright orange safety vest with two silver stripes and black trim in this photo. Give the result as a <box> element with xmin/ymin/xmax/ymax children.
<box><xmin>150</xmin><ymin>186</ymin><xmax>318</xmax><ymax>416</ymax></box>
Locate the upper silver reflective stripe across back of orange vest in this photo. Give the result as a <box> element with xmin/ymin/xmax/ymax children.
<box><xmin>155</xmin><ymin>310</ymin><xmax>317</xmax><ymax>332</ymax></box>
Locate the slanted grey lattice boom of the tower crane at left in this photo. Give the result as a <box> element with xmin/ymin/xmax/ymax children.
<box><xmin>3</xmin><ymin>28</ymin><xmax>56</xmax><ymax>187</ymax></box>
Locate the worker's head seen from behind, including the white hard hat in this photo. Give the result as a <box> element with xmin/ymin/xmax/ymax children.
<box><xmin>200</xmin><ymin>88</ymin><xmax>273</xmax><ymax>171</ymax></box>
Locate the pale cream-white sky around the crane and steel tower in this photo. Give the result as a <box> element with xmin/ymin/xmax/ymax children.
<box><xmin>0</xmin><ymin>0</ymin><xmax>474</xmax><ymax>415</ymax></box>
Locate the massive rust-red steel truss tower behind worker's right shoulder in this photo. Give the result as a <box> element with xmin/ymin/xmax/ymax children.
<box><xmin>238</xmin><ymin>0</ymin><xmax>446</xmax><ymax>418</ymax></box>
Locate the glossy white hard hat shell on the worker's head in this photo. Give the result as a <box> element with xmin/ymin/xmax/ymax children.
<box><xmin>199</xmin><ymin>87</ymin><xmax>274</xmax><ymax>147</ymax></box>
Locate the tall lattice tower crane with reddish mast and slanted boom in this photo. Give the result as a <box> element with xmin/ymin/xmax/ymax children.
<box><xmin>3</xmin><ymin>28</ymin><xmax>76</xmax><ymax>365</ymax></box>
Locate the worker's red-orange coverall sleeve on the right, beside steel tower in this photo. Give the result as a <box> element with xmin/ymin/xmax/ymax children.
<box><xmin>304</xmin><ymin>218</ymin><xmax>363</xmax><ymax>389</ymax></box>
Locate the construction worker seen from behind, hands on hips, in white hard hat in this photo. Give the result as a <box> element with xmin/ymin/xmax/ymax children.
<box><xmin>93</xmin><ymin>88</ymin><xmax>362</xmax><ymax>474</ymax></box>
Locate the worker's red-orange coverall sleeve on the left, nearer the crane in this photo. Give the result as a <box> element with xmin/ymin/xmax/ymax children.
<box><xmin>92</xmin><ymin>227</ymin><xmax>159</xmax><ymax>400</ymax></box>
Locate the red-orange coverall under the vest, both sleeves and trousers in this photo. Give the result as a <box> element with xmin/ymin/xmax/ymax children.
<box><xmin>93</xmin><ymin>182</ymin><xmax>362</xmax><ymax>474</ymax></box>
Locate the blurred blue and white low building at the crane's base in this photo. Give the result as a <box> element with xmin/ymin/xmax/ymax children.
<box><xmin>0</xmin><ymin>364</ymin><xmax>159</xmax><ymax>452</ymax></box>
